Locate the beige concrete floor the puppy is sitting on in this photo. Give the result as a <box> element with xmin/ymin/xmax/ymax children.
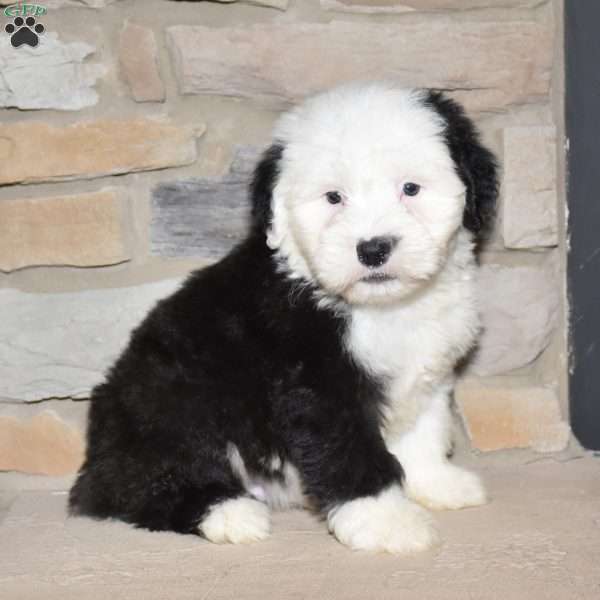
<box><xmin>0</xmin><ymin>454</ymin><xmax>600</xmax><ymax>600</ymax></box>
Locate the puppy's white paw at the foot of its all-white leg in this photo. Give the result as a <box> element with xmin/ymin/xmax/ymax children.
<box><xmin>404</xmin><ymin>463</ymin><xmax>487</xmax><ymax>510</ymax></box>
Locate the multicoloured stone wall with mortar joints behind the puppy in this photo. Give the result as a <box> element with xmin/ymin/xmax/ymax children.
<box><xmin>0</xmin><ymin>0</ymin><xmax>569</xmax><ymax>475</ymax></box>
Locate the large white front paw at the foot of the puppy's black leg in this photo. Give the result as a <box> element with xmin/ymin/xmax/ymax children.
<box><xmin>327</xmin><ymin>486</ymin><xmax>439</xmax><ymax>554</ymax></box>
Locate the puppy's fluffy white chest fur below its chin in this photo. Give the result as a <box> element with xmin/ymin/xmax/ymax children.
<box><xmin>346</xmin><ymin>234</ymin><xmax>479</xmax><ymax>433</ymax></box>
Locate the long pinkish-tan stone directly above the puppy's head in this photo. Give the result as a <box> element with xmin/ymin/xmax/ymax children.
<box><xmin>167</xmin><ymin>15</ymin><xmax>553</xmax><ymax>111</ymax></box>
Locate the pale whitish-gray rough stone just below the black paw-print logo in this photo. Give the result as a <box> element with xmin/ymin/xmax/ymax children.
<box><xmin>0</xmin><ymin>33</ymin><xmax>105</xmax><ymax>110</ymax></box>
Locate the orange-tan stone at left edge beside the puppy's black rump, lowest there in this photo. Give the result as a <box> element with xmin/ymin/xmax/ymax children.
<box><xmin>0</xmin><ymin>411</ymin><xmax>84</xmax><ymax>476</ymax></box>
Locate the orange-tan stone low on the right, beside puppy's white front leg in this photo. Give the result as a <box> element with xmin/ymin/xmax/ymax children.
<box><xmin>455</xmin><ymin>379</ymin><xmax>569</xmax><ymax>452</ymax></box>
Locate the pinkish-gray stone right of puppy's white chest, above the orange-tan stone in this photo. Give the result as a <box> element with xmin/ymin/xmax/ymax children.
<box><xmin>468</xmin><ymin>261</ymin><xmax>561</xmax><ymax>375</ymax></box>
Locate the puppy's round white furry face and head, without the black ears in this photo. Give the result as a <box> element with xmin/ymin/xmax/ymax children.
<box><xmin>268</xmin><ymin>86</ymin><xmax>496</xmax><ymax>304</ymax></box>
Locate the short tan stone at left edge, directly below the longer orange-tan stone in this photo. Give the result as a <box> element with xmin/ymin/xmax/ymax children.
<box><xmin>0</xmin><ymin>189</ymin><xmax>130</xmax><ymax>271</ymax></box>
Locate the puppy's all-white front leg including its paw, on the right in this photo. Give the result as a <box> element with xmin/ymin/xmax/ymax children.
<box><xmin>387</xmin><ymin>386</ymin><xmax>487</xmax><ymax>510</ymax></box>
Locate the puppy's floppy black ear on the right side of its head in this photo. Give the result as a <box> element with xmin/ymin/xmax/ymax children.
<box><xmin>425</xmin><ymin>90</ymin><xmax>498</xmax><ymax>238</ymax></box>
